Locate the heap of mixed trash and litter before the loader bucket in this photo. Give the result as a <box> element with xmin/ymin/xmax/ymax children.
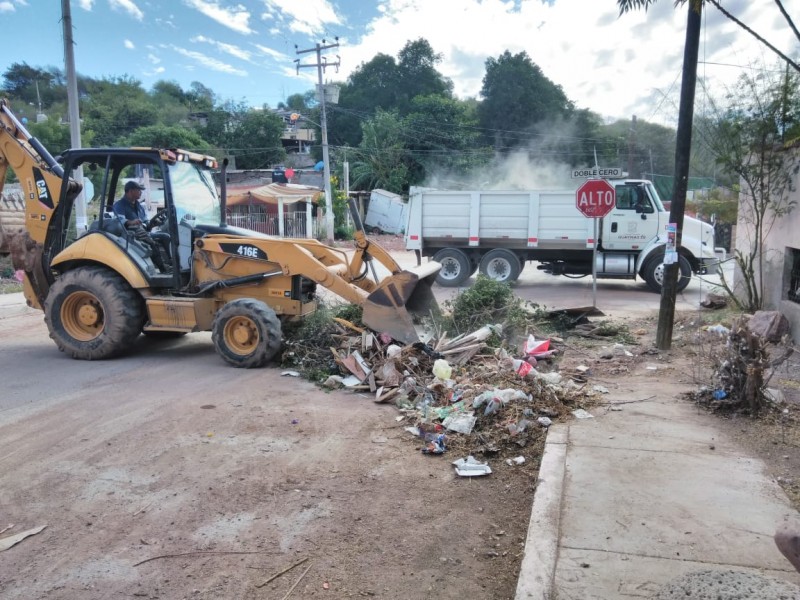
<box><xmin>289</xmin><ymin>318</ymin><xmax>600</xmax><ymax>462</ymax></box>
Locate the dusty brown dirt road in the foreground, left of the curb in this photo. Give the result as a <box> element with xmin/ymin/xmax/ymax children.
<box><xmin>0</xmin><ymin>307</ymin><xmax>538</xmax><ymax>600</ymax></box>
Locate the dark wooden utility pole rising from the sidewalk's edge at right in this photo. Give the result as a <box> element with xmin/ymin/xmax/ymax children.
<box><xmin>656</xmin><ymin>1</ymin><xmax>703</xmax><ymax>350</ymax></box>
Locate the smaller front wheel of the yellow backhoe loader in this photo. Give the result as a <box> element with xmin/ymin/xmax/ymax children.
<box><xmin>211</xmin><ymin>298</ymin><xmax>281</xmax><ymax>369</ymax></box>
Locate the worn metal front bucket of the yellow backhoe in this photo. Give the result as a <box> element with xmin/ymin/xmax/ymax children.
<box><xmin>362</xmin><ymin>262</ymin><xmax>442</xmax><ymax>344</ymax></box>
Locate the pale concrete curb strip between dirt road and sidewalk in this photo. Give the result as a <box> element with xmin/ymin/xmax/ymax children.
<box><xmin>515</xmin><ymin>424</ymin><xmax>569</xmax><ymax>600</ymax></box>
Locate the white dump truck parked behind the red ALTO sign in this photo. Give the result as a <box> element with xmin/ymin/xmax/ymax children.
<box><xmin>405</xmin><ymin>179</ymin><xmax>718</xmax><ymax>291</ymax></box>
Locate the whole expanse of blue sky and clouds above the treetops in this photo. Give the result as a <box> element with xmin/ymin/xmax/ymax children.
<box><xmin>0</xmin><ymin>0</ymin><xmax>800</xmax><ymax>126</ymax></box>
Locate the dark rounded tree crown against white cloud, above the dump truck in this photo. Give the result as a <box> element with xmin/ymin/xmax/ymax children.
<box><xmin>478</xmin><ymin>50</ymin><xmax>573</xmax><ymax>151</ymax></box>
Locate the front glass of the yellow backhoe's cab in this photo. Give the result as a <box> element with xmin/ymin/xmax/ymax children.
<box><xmin>169</xmin><ymin>162</ymin><xmax>220</xmax><ymax>225</ymax></box>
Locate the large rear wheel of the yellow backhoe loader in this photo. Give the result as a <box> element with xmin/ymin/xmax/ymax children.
<box><xmin>44</xmin><ymin>267</ymin><xmax>144</xmax><ymax>360</ymax></box>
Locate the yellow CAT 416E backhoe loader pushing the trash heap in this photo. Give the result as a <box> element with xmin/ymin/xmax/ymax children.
<box><xmin>0</xmin><ymin>100</ymin><xmax>440</xmax><ymax>367</ymax></box>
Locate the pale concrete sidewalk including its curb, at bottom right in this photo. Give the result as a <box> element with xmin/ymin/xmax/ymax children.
<box><xmin>516</xmin><ymin>390</ymin><xmax>800</xmax><ymax>600</ymax></box>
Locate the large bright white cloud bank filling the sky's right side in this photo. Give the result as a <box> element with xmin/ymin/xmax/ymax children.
<box><xmin>340</xmin><ymin>0</ymin><xmax>800</xmax><ymax>124</ymax></box>
